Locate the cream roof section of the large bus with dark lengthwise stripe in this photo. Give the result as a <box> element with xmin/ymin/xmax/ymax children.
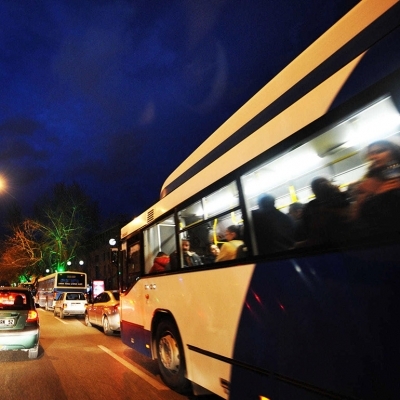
<box><xmin>121</xmin><ymin>0</ymin><xmax>398</xmax><ymax>238</ymax></box>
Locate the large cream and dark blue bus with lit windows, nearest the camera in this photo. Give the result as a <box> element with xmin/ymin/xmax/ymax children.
<box><xmin>120</xmin><ymin>0</ymin><xmax>400</xmax><ymax>400</ymax></box>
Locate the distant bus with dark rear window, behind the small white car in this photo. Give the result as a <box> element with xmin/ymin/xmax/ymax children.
<box><xmin>35</xmin><ymin>271</ymin><xmax>87</xmax><ymax>310</ymax></box>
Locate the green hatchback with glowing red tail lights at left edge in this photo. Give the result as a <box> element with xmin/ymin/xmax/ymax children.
<box><xmin>0</xmin><ymin>286</ymin><xmax>40</xmax><ymax>358</ymax></box>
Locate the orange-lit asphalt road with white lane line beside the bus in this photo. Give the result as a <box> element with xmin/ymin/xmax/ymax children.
<box><xmin>0</xmin><ymin>309</ymin><xmax>219</xmax><ymax>400</ymax></box>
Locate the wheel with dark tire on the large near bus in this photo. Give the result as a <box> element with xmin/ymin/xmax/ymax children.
<box><xmin>156</xmin><ymin>319</ymin><xmax>191</xmax><ymax>394</ymax></box>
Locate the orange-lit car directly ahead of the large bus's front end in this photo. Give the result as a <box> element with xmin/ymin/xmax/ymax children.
<box><xmin>85</xmin><ymin>290</ymin><xmax>121</xmax><ymax>335</ymax></box>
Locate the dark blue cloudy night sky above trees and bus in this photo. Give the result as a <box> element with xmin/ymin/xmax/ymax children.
<box><xmin>0</xmin><ymin>0</ymin><xmax>358</xmax><ymax>222</ymax></box>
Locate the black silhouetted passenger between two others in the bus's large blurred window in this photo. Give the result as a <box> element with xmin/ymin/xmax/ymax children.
<box><xmin>302</xmin><ymin>177</ymin><xmax>351</xmax><ymax>246</ymax></box>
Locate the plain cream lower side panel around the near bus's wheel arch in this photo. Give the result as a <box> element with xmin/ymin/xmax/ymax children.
<box><xmin>121</xmin><ymin>264</ymin><xmax>255</xmax><ymax>397</ymax></box>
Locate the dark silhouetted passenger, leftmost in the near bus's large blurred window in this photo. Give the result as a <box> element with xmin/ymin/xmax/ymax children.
<box><xmin>252</xmin><ymin>194</ymin><xmax>294</xmax><ymax>254</ymax></box>
